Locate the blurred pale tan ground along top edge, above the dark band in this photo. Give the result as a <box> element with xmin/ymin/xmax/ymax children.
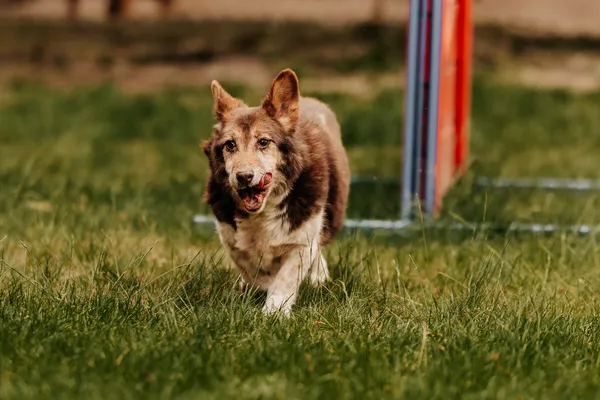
<box><xmin>0</xmin><ymin>0</ymin><xmax>600</xmax><ymax>36</ymax></box>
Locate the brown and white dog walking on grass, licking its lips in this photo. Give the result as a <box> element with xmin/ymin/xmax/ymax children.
<box><xmin>203</xmin><ymin>69</ymin><xmax>350</xmax><ymax>315</ymax></box>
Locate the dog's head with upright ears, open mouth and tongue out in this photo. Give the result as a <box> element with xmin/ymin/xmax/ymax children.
<box><xmin>203</xmin><ymin>69</ymin><xmax>300</xmax><ymax>213</ymax></box>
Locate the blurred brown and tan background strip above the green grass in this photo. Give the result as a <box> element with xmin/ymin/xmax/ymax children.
<box><xmin>0</xmin><ymin>0</ymin><xmax>600</xmax><ymax>92</ymax></box>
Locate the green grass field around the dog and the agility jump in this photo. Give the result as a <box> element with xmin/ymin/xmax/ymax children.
<box><xmin>0</xmin><ymin>79</ymin><xmax>600</xmax><ymax>400</ymax></box>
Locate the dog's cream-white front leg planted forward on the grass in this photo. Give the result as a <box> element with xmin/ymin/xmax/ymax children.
<box><xmin>263</xmin><ymin>246</ymin><xmax>319</xmax><ymax>316</ymax></box>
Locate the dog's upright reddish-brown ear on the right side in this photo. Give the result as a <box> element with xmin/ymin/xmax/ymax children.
<box><xmin>262</xmin><ymin>69</ymin><xmax>300</xmax><ymax>129</ymax></box>
